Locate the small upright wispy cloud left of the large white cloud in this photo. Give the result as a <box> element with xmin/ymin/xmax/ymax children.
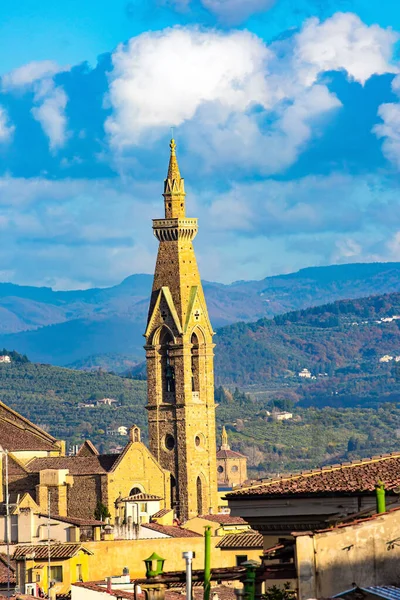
<box><xmin>32</xmin><ymin>79</ymin><xmax>68</xmax><ymax>151</ymax></box>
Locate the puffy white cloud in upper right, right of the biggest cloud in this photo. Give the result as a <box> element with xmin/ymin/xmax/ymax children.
<box><xmin>295</xmin><ymin>13</ymin><xmax>399</xmax><ymax>85</ymax></box>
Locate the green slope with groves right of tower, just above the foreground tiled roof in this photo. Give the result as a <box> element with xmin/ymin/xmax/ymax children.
<box><xmin>217</xmin><ymin>388</ymin><xmax>400</xmax><ymax>478</ymax></box>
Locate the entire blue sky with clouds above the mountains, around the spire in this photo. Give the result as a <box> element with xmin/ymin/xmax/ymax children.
<box><xmin>0</xmin><ymin>0</ymin><xmax>400</xmax><ymax>289</ymax></box>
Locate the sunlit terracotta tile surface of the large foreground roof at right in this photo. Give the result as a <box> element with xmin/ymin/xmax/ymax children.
<box><xmin>227</xmin><ymin>452</ymin><xmax>400</xmax><ymax>500</ymax></box>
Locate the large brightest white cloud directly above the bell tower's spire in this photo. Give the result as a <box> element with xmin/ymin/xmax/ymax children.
<box><xmin>106</xmin><ymin>28</ymin><xmax>270</xmax><ymax>147</ymax></box>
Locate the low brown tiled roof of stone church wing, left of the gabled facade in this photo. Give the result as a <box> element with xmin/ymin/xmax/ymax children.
<box><xmin>26</xmin><ymin>454</ymin><xmax>119</xmax><ymax>475</ymax></box>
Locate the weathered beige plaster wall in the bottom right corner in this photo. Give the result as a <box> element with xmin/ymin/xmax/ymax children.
<box><xmin>296</xmin><ymin>509</ymin><xmax>400</xmax><ymax>600</ymax></box>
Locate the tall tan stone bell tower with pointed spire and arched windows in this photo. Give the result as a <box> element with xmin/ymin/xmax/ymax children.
<box><xmin>145</xmin><ymin>140</ymin><xmax>218</xmax><ymax>520</ymax></box>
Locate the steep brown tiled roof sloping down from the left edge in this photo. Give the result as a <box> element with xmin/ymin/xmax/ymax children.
<box><xmin>0</xmin><ymin>402</ymin><xmax>57</xmax><ymax>452</ymax></box>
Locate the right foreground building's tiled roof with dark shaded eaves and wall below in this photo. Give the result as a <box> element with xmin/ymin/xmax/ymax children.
<box><xmin>226</xmin><ymin>452</ymin><xmax>400</xmax><ymax>547</ymax></box>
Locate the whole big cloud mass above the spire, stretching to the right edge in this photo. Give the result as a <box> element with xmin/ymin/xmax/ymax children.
<box><xmin>106</xmin><ymin>13</ymin><xmax>397</xmax><ymax>175</ymax></box>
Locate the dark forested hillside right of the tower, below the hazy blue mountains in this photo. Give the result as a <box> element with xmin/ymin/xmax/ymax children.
<box><xmin>215</xmin><ymin>293</ymin><xmax>400</xmax><ymax>404</ymax></box>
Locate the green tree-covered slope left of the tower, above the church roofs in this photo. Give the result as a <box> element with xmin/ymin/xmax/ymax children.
<box><xmin>0</xmin><ymin>362</ymin><xmax>147</xmax><ymax>452</ymax></box>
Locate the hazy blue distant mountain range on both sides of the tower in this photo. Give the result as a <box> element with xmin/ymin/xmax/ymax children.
<box><xmin>0</xmin><ymin>263</ymin><xmax>400</xmax><ymax>370</ymax></box>
